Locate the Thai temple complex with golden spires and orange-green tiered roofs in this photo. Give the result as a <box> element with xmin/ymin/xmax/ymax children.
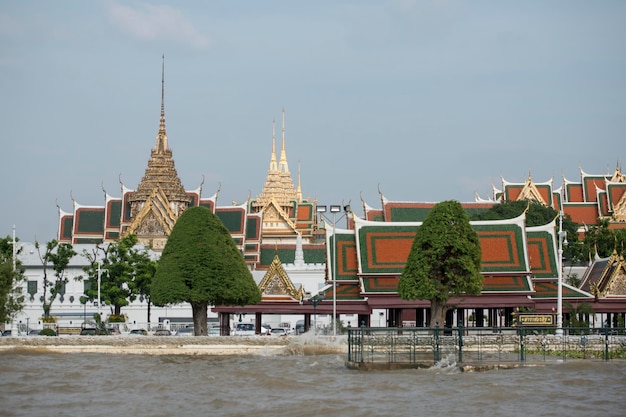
<box><xmin>14</xmin><ymin>62</ymin><xmax>626</xmax><ymax>334</ymax></box>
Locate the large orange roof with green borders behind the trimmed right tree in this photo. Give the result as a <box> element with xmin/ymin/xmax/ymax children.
<box><xmin>314</xmin><ymin>197</ymin><xmax>592</xmax><ymax>309</ymax></box>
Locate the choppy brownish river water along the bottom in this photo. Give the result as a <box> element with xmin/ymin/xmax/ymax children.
<box><xmin>0</xmin><ymin>342</ymin><xmax>626</xmax><ymax>417</ymax></box>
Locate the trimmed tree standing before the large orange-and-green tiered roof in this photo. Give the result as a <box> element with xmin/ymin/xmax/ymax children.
<box><xmin>398</xmin><ymin>200</ymin><xmax>483</xmax><ymax>327</ymax></box>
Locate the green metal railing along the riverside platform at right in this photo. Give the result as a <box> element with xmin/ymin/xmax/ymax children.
<box><xmin>347</xmin><ymin>327</ymin><xmax>626</xmax><ymax>367</ymax></box>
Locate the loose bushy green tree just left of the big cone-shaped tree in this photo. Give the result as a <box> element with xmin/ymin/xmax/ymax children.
<box><xmin>81</xmin><ymin>235</ymin><xmax>155</xmax><ymax>317</ymax></box>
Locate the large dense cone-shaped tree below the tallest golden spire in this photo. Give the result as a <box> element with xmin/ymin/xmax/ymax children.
<box><xmin>150</xmin><ymin>207</ymin><xmax>261</xmax><ymax>335</ymax></box>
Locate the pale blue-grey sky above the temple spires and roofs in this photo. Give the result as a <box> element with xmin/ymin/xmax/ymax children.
<box><xmin>0</xmin><ymin>0</ymin><xmax>626</xmax><ymax>242</ymax></box>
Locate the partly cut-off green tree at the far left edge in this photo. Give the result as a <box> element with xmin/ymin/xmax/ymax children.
<box><xmin>0</xmin><ymin>236</ymin><xmax>26</xmax><ymax>323</ymax></box>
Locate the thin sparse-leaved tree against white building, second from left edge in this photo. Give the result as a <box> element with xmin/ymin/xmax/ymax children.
<box><xmin>35</xmin><ymin>239</ymin><xmax>76</xmax><ymax>321</ymax></box>
